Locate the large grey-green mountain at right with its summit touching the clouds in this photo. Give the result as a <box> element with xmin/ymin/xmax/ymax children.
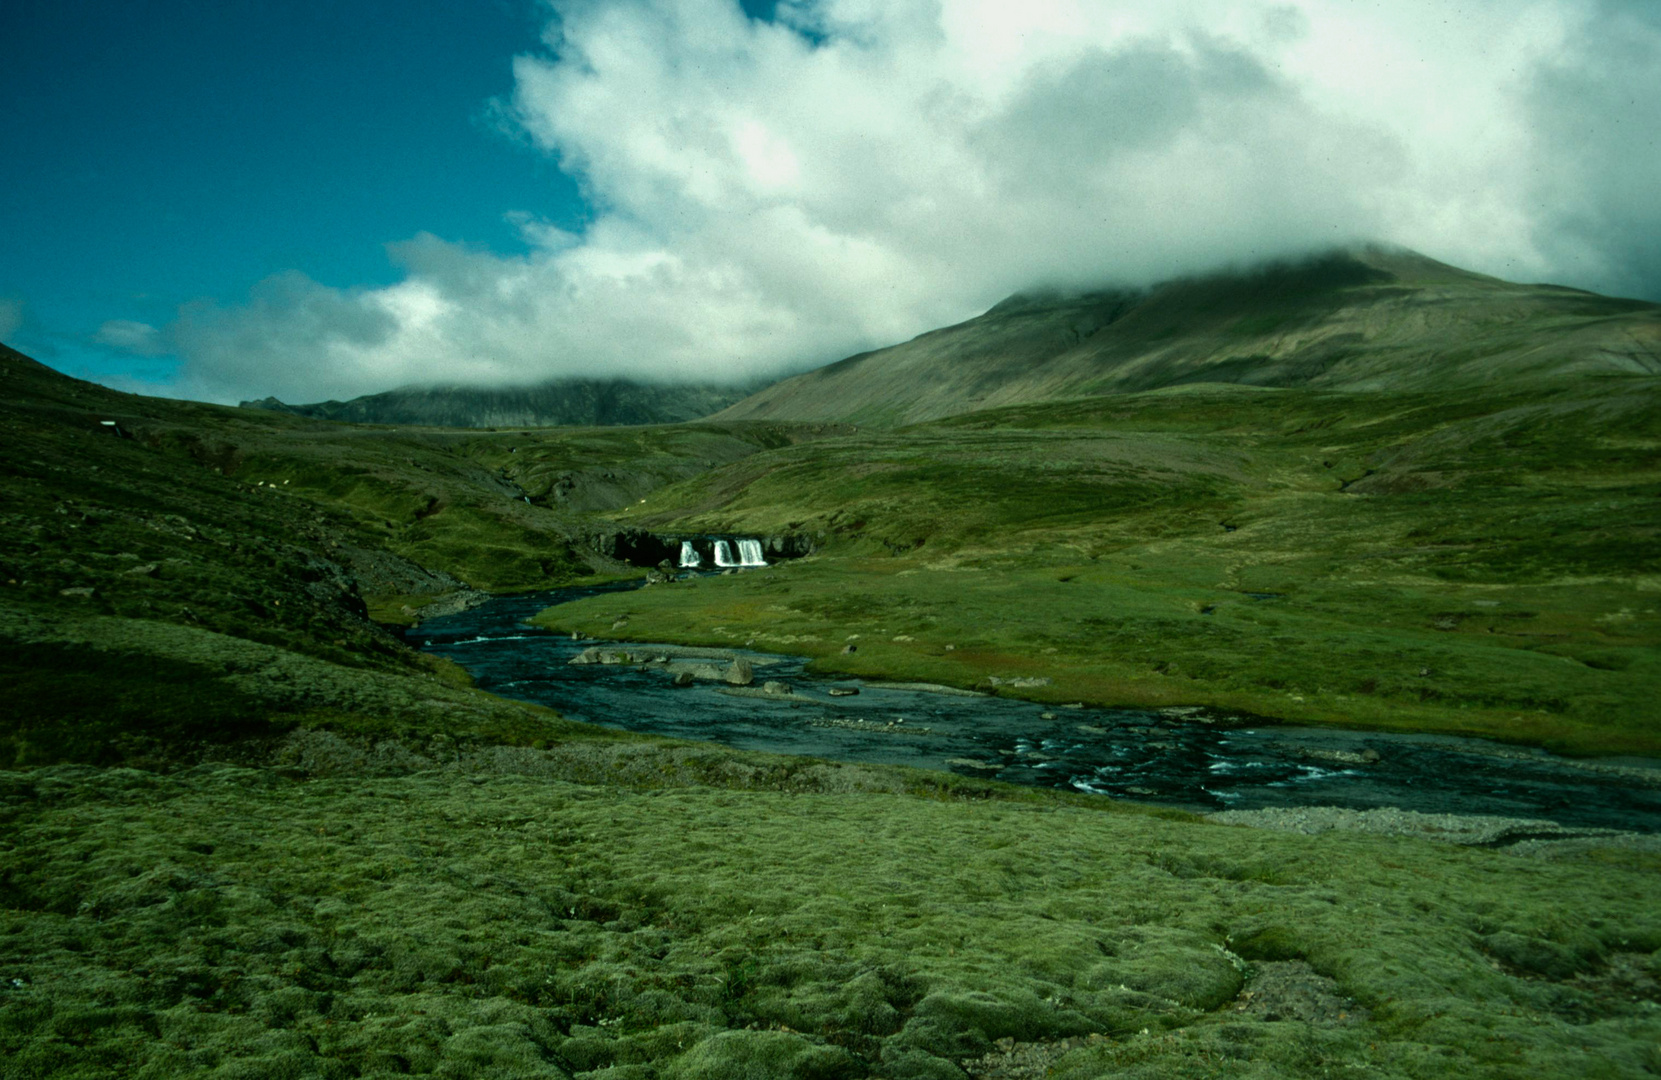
<box><xmin>716</xmin><ymin>248</ymin><xmax>1661</xmax><ymax>425</ymax></box>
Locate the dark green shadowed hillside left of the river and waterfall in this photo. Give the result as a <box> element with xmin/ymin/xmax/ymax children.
<box><xmin>0</xmin><ymin>346</ymin><xmax>830</xmax><ymax>766</ymax></box>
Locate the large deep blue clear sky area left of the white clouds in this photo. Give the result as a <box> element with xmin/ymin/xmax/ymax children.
<box><xmin>0</xmin><ymin>0</ymin><xmax>586</xmax><ymax>385</ymax></box>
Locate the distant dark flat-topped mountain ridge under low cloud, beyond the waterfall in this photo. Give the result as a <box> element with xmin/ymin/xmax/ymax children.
<box><xmin>243</xmin><ymin>379</ymin><xmax>756</xmax><ymax>427</ymax></box>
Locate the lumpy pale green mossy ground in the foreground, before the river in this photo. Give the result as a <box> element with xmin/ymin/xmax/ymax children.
<box><xmin>0</xmin><ymin>743</ymin><xmax>1661</xmax><ymax>1080</ymax></box>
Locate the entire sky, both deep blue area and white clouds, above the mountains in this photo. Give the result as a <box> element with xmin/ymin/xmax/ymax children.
<box><xmin>0</xmin><ymin>0</ymin><xmax>1661</xmax><ymax>402</ymax></box>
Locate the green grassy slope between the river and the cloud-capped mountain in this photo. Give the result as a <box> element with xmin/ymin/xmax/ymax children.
<box><xmin>538</xmin><ymin>380</ymin><xmax>1661</xmax><ymax>754</ymax></box>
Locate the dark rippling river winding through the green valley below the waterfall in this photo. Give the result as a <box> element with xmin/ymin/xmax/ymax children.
<box><xmin>407</xmin><ymin>583</ymin><xmax>1661</xmax><ymax>832</ymax></box>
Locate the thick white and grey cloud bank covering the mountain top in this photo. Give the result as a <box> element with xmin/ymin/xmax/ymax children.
<box><xmin>158</xmin><ymin>0</ymin><xmax>1661</xmax><ymax>400</ymax></box>
